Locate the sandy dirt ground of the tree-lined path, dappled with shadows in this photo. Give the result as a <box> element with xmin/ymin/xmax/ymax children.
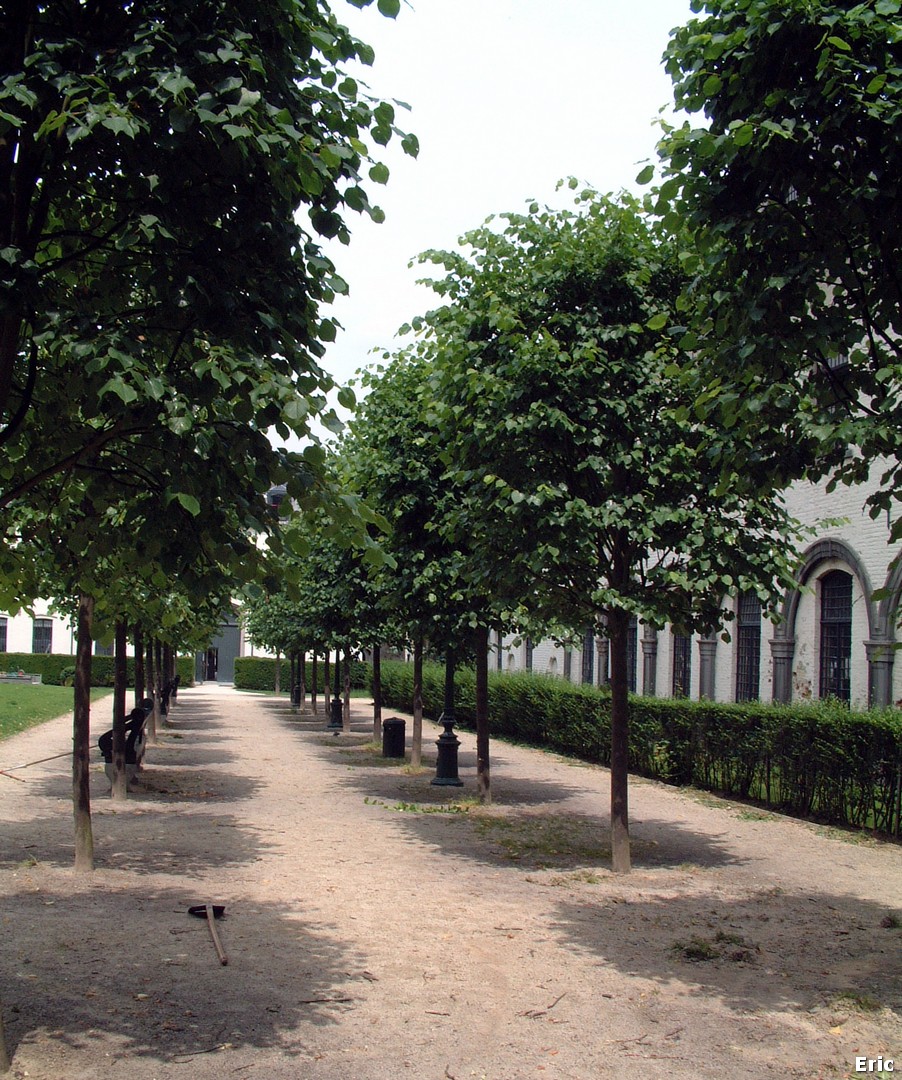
<box><xmin>0</xmin><ymin>685</ymin><xmax>902</xmax><ymax>1080</ymax></box>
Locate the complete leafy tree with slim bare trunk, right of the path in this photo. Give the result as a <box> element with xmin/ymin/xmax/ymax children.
<box><xmin>422</xmin><ymin>191</ymin><xmax>792</xmax><ymax>872</ymax></box>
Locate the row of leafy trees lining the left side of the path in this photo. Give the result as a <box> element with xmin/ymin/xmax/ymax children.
<box><xmin>0</xmin><ymin>0</ymin><xmax>417</xmax><ymax>869</ymax></box>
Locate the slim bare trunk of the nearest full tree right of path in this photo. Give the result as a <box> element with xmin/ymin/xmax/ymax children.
<box><xmin>607</xmin><ymin>608</ymin><xmax>630</xmax><ymax>874</ymax></box>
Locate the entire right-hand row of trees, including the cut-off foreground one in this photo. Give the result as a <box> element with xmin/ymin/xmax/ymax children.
<box><xmin>245</xmin><ymin>0</ymin><xmax>902</xmax><ymax>870</ymax></box>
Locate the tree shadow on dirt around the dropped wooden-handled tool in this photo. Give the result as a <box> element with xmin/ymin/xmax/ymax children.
<box><xmin>0</xmin><ymin>873</ymin><xmax>371</xmax><ymax>1075</ymax></box>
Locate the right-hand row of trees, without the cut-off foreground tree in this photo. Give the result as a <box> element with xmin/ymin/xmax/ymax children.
<box><xmin>243</xmin><ymin>191</ymin><xmax>808</xmax><ymax>870</ymax></box>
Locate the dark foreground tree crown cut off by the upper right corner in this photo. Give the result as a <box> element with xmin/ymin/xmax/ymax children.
<box><xmin>641</xmin><ymin>0</ymin><xmax>902</xmax><ymax>527</ymax></box>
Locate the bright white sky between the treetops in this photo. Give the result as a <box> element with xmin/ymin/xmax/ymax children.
<box><xmin>311</xmin><ymin>0</ymin><xmax>691</xmax><ymax>408</ymax></box>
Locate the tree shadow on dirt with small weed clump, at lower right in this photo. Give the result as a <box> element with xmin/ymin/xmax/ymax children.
<box><xmin>552</xmin><ymin>885</ymin><xmax>902</xmax><ymax>1030</ymax></box>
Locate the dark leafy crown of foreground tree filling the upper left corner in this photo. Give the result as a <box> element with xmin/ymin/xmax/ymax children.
<box><xmin>0</xmin><ymin>0</ymin><xmax>416</xmax><ymax>518</ymax></box>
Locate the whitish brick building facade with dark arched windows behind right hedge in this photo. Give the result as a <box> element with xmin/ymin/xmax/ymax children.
<box><xmin>494</xmin><ymin>463</ymin><xmax>902</xmax><ymax>708</ymax></box>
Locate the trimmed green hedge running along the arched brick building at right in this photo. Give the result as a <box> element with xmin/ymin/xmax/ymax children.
<box><xmin>382</xmin><ymin>663</ymin><xmax>902</xmax><ymax>836</ymax></box>
